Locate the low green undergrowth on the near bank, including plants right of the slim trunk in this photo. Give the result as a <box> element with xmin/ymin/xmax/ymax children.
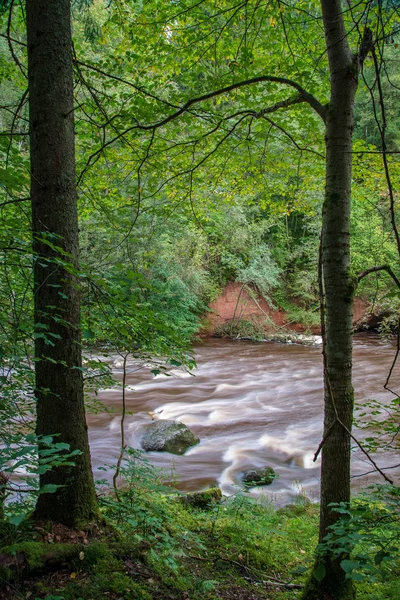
<box><xmin>2</xmin><ymin>450</ymin><xmax>399</xmax><ymax>600</ymax></box>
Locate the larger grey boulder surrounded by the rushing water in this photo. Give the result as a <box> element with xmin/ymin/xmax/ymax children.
<box><xmin>141</xmin><ymin>420</ymin><xmax>200</xmax><ymax>454</ymax></box>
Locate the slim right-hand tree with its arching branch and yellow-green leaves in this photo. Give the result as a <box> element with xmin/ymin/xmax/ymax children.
<box><xmin>74</xmin><ymin>0</ymin><xmax>395</xmax><ymax>598</ymax></box>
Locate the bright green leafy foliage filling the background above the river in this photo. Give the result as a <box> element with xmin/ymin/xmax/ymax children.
<box><xmin>0</xmin><ymin>0</ymin><xmax>398</xmax><ymax>591</ymax></box>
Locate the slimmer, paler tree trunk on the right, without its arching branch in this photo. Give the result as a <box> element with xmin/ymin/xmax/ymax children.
<box><xmin>305</xmin><ymin>0</ymin><xmax>359</xmax><ymax>599</ymax></box>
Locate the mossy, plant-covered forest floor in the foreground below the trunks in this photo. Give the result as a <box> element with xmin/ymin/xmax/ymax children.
<box><xmin>0</xmin><ymin>479</ymin><xmax>400</xmax><ymax>600</ymax></box>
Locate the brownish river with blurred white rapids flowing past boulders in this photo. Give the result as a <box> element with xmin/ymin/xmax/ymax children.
<box><xmin>88</xmin><ymin>334</ymin><xmax>400</xmax><ymax>504</ymax></box>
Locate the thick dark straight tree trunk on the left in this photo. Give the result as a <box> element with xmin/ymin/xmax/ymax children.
<box><xmin>26</xmin><ymin>0</ymin><xmax>96</xmax><ymax>525</ymax></box>
